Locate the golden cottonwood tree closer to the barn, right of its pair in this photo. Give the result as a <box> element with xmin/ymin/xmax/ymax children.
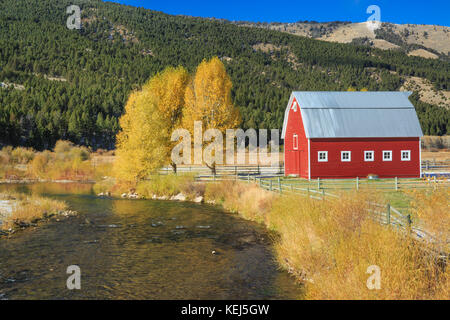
<box><xmin>182</xmin><ymin>57</ymin><xmax>241</xmax><ymax>172</ymax></box>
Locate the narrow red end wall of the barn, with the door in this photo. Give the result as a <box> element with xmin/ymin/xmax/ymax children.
<box><xmin>284</xmin><ymin>98</ymin><xmax>308</xmax><ymax>178</ymax></box>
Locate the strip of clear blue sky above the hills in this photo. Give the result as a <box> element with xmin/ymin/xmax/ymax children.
<box><xmin>111</xmin><ymin>0</ymin><xmax>450</xmax><ymax>26</ymax></box>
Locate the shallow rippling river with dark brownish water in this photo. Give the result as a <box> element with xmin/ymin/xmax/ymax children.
<box><xmin>0</xmin><ymin>183</ymin><xmax>302</xmax><ymax>299</ymax></box>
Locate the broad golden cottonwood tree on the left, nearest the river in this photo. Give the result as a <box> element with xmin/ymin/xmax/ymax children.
<box><xmin>114</xmin><ymin>67</ymin><xmax>189</xmax><ymax>181</ymax></box>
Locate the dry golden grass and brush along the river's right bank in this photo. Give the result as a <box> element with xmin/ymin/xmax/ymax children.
<box><xmin>205</xmin><ymin>181</ymin><xmax>450</xmax><ymax>299</ymax></box>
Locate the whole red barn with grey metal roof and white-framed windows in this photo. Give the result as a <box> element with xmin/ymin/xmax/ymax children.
<box><xmin>282</xmin><ymin>92</ymin><xmax>423</xmax><ymax>179</ymax></box>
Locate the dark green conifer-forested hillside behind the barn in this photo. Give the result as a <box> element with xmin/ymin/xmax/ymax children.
<box><xmin>0</xmin><ymin>0</ymin><xmax>450</xmax><ymax>149</ymax></box>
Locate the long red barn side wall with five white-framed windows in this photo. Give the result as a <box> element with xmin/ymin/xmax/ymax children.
<box><xmin>310</xmin><ymin>138</ymin><xmax>420</xmax><ymax>178</ymax></box>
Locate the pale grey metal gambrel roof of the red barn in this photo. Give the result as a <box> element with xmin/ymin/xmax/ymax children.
<box><xmin>282</xmin><ymin>91</ymin><xmax>423</xmax><ymax>139</ymax></box>
